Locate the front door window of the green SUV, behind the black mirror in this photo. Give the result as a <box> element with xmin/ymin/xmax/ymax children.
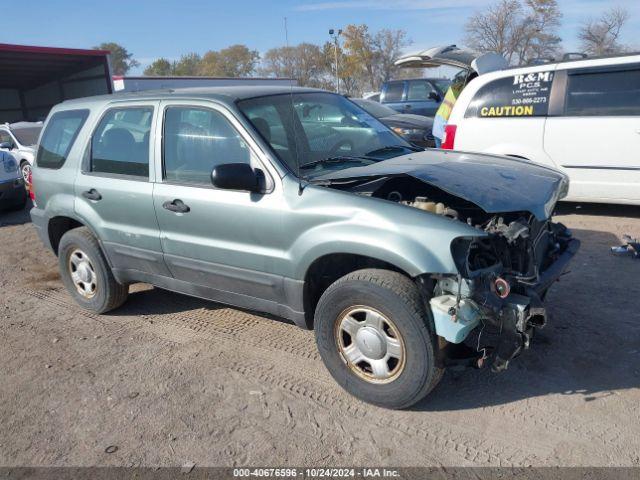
<box><xmin>162</xmin><ymin>107</ymin><xmax>251</xmax><ymax>185</ymax></box>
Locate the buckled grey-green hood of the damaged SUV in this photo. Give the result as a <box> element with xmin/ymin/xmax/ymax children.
<box><xmin>313</xmin><ymin>150</ymin><xmax>569</xmax><ymax>220</ymax></box>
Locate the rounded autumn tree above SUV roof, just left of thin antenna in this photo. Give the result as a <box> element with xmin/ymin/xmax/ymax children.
<box><xmin>198</xmin><ymin>45</ymin><xmax>260</xmax><ymax>77</ymax></box>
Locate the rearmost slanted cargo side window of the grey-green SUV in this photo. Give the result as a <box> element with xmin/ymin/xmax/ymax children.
<box><xmin>36</xmin><ymin>110</ymin><xmax>89</xmax><ymax>168</ymax></box>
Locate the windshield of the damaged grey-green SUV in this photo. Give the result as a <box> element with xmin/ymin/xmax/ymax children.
<box><xmin>238</xmin><ymin>92</ymin><xmax>413</xmax><ymax>177</ymax></box>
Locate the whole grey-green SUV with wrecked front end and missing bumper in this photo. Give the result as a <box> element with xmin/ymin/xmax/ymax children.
<box><xmin>31</xmin><ymin>86</ymin><xmax>579</xmax><ymax>408</ymax></box>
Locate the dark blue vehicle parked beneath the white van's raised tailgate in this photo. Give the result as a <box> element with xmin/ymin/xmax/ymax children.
<box><xmin>380</xmin><ymin>78</ymin><xmax>446</xmax><ymax>117</ymax></box>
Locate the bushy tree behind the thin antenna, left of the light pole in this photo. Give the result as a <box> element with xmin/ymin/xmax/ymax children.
<box><xmin>260</xmin><ymin>43</ymin><xmax>330</xmax><ymax>88</ymax></box>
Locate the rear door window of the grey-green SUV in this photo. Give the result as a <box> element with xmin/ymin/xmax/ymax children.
<box><xmin>89</xmin><ymin>107</ymin><xmax>153</xmax><ymax>178</ymax></box>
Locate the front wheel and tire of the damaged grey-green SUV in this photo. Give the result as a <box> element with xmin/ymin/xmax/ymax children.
<box><xmin>314</xmin><ymin>269</ymin><xmax>444</xmax><ymax>409</ymax></box>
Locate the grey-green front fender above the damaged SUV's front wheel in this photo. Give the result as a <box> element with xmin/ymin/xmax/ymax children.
<box><xmin>290</xmin><ymin>185</ymin><xmax>484</xmax><ymax>279</ymax></box>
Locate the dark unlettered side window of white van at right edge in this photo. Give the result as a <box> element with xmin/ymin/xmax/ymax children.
<box><xmin>565</xmin><ymin>68</ymin><xmax>640</xmax><ymax>116</ymax></box>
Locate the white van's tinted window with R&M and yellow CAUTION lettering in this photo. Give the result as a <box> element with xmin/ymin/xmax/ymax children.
<box><xmin>465</xmin><ymin>72</ymin><xmax>554</xmax><ymax>118</ymax></box>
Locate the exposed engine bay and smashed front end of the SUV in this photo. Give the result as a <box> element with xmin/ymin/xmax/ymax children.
<box><xmin>330</xmin><ymin>176</ymin><xmax>580</xmax><ymax>371</ymax></box>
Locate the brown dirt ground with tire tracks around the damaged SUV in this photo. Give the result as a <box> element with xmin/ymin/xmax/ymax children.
<box><xmin>0</xmin><ymin>204</ymin><xmax>640</xmax><ymax>466</ymax></box>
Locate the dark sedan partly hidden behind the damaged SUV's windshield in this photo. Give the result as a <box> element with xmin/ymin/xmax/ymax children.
<box><xmin>351</xmin><ymin>98</ymin><xmax>436</xmax><ymax>148</ymax></box>
